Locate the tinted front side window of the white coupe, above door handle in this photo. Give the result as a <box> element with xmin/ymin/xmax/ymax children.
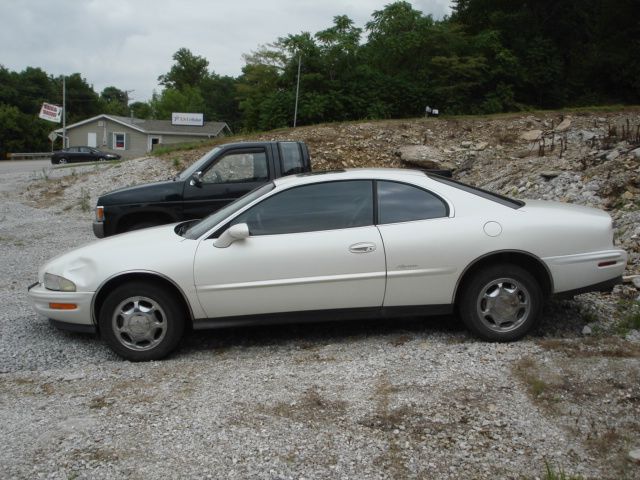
<box><xmin>233</xmin><ymin>180</ymin><xmax>373</xmax><ymax>235</ymax></box>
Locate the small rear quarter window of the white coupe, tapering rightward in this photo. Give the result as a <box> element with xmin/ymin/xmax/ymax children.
<box><xmin>376</xmin><ymin>181</ymin><xmax>449</xmax><ymax>224</ymax></box>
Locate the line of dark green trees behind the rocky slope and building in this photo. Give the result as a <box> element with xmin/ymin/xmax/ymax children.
<box><xmin>0</xmin><ymin>0</ymin><xmax>640</xmax><ymax>151</ymax></box>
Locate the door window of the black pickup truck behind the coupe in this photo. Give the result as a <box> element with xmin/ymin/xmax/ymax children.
<box><xmin>202</xmin><ymin>151</ymin><xmax>269</xmax><ymax>183</ymax></box>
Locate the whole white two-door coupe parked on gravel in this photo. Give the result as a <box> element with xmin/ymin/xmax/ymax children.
<box><xmin>29</xmin><ymin>169</ymin><xmax>627</xmax><ymax>361</ymax></box>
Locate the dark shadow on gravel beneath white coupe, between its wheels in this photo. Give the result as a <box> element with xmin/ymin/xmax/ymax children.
<box><xmin>181</xmin><ymin>316</ymin><xmax>471</xmax><ymax>352</ymax></box>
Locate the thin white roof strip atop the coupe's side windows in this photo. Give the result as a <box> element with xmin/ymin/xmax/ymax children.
<box><xmin>274</xmin><ymin>168</ymin><xmax>426</xmax><ymax>187</ymax></box>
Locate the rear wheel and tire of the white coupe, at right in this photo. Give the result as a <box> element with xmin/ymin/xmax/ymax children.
<box><xmin>458</xmin><ymin>264</ymin><xmax>543</xmax><ymax>342</ymax></box>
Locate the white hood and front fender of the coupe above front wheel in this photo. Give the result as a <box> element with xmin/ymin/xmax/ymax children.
<box><xmin>38</xmin><ymin>224</ymin><xmax>197</xmax><ymax>291</ymax></box>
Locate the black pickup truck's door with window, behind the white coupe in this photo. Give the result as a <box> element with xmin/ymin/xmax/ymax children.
<box><xmin>183</xmin><ymin>148</ymin><xmax>270</xmax><ymax>218</ymax></box>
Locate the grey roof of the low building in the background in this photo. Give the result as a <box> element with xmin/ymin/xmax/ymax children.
<box><xmin>55</xmin><ymin>114</ymin><xmax>231</xmax><ymax>137</ymax></box>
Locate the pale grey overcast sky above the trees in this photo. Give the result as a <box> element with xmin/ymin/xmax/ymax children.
<box><xmin>0</xmin><ymin>0</ymin><xmax>451</xmax><ymax>101</ymax></box>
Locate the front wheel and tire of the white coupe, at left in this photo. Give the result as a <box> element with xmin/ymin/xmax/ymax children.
<box><xmin>98</xmin><ymin>282</ymin><xmax>185</xmax><ymax>362</ymax></box>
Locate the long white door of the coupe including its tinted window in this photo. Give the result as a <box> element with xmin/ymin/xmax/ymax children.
<box><xmin>194</xmin><ymin>180</ymin><xmax>386</xmax><ymax>318</ymax></box>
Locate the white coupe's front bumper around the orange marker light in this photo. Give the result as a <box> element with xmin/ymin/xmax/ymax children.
<box><xmin>28</xmin><ymin>283</ymin><xmax>95</xmax><ymax>327</ymax></box>
